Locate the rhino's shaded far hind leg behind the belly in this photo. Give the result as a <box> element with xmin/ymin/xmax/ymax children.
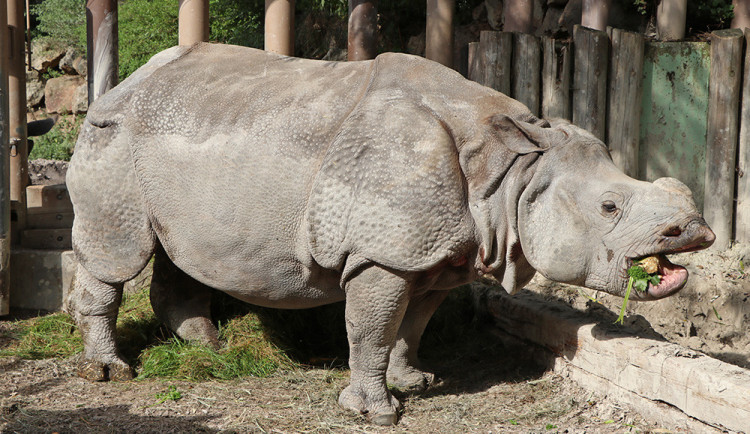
<box><xmin>151</xmin><ymin>248</ymin><xmax>220</xmax><ymax>349</ymax></box>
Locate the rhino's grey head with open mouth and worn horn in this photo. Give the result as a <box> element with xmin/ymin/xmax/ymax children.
<box><xmin>518</xmin><ymin>121</ymin><xmax>715</xmax><ymax>300</ymax></box>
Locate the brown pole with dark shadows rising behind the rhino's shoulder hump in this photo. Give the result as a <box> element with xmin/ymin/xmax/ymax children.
<box><xmin>347</xmin><ymin>0</ymin><xmax>378</xmax><ymax>60</ymax></box>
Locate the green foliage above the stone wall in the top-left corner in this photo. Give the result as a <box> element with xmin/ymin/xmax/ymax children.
<box><xmin>30</xmin><ymin>0</ymin><xmax>86</xmax><ymax>52</ymax></box>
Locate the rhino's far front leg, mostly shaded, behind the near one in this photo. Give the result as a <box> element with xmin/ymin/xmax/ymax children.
<box><xmin>386</xmin><ymin>291</ymin><xmax>448</xmax><ymax>392</ymax></box>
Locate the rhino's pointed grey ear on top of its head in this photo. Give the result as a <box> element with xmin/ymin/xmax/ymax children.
<box><xmin>486</xmin><ymin>115</ymin><xmax>568</xmax><ymax>154</ymax></box>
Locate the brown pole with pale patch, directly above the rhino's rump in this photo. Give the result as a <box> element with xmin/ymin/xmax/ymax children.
<box><xmin>86</xmin><ymin>0</ymin><xmax>119</xmax><ymax>104</ymax></box>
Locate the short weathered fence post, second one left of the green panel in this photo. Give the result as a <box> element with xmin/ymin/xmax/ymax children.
<box><xmin>573</xmin><ymin>25</ymin><xmax>609</xmax><ymax>140</ymax></box>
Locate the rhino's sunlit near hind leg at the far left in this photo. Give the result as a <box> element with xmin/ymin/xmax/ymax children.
<box><xmin>68</xmin><ymin>264</ymin><xmax>133</xmax><ymax>381</ymax></box>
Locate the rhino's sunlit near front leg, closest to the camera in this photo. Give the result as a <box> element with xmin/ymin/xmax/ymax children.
<box><xmin>339</xmin><ymin>266</ymin><xmax>410</xmax><ymax>425</ymax></box>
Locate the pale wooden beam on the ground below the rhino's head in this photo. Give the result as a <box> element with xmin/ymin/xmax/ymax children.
<box><xmin>487</xmin><ymin>289</ymin><xmax>750</xmax><ymax>432</ymax></box>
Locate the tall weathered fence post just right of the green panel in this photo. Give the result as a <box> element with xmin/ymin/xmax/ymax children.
<box><xmin>703</xmin><ymin>29</ymin><xmax>744</xmax><ymax>250</ymax></box>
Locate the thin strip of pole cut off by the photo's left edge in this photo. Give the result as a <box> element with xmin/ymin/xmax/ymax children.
<box><xmin>0</xmin><ymin>1</ymin><xmax>11</xmax><ymax>315</ymax></box>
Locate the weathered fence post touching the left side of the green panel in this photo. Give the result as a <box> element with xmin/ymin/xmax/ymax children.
<box><xmin>607</xmin><ymin>29</ymin><xmax>644</xmax><ymax>178</ymax></box>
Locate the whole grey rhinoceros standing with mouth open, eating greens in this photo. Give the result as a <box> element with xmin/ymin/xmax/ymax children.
<box><xmin>67</xmin><ymin>44</ymin><xmax>714</xmax><ymax>425</ymax></box>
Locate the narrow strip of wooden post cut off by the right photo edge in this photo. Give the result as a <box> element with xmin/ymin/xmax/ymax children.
<box><xmin>735</xmin><ymin>29</ymin><xmax>750</xmax><ymax>243</ymax></box>
